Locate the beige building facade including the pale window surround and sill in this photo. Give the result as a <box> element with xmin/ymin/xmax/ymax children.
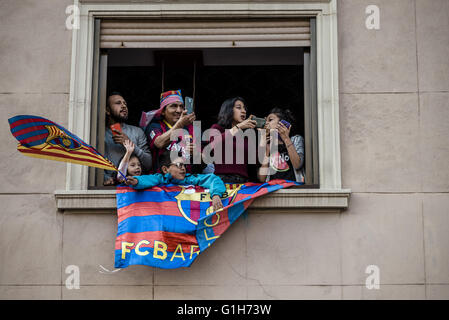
<box><xmin>0</xmin><ymin>0</ymin><xmax>449</xmax><ymax>299</ymax></box>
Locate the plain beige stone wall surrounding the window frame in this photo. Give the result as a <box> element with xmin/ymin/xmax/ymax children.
<box><xmin>0</xmin><ymin>0</ymin><xmax>449</xmax><ymax>299</ymax></box>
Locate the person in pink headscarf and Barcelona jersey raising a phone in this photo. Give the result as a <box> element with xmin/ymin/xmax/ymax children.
<box><xmin>145</xmin><ymin>90</ymin><xmax>195</xmax><ymax>173</ymax></box>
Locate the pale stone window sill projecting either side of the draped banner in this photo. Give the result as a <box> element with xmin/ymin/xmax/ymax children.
<box><xmin>55</xmin><ymin>188</ymin><xmax>351</xmax><ymax>213</ymax></box>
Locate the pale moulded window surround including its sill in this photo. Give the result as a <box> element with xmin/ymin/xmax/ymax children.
<box><xmin>55</xmin><ymin>0</ymin><xmax>350</xmax><ymax>211</ymax></box>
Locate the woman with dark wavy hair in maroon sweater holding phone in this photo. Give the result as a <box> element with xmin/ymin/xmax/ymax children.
<box><xmin>206</xmin><ymin>97</ymin><xmax>256</xmax><ymax>183</ymax></box>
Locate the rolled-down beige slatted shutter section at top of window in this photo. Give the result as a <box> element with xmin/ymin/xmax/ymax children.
<box><xmin>100</xmin><ymin>19</ymin><xmax>310</xmax><ymax>48</ymax></box>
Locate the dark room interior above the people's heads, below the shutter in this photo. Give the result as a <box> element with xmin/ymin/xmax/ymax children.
<box><xmin>107</xmin><ymin>48</ymin><xmax>304</xmax><ymax>137</ymax></box>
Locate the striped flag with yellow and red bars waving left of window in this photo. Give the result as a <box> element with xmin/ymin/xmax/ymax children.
<box><xmin>8</xmin><ymin>115</ymin><xmax>117</xmax><ymax>171</ymax></box>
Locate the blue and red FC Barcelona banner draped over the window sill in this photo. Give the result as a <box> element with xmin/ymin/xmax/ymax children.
<box><xmin>115</xmin><ymin>180</ymin><xmax>300</xmax><ymax>269</ymax></box>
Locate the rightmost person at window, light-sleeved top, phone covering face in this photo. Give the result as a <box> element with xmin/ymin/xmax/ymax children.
<box><xmin>257</xmin><ymin>108</ymin><xmax>304</xmax><ymax>182</ymax></box>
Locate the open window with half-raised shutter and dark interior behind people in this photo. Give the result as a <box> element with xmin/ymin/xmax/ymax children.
<box><xmin>89</xmin><ymin>18</ymin><xmax>319</xmax><ymax>189</ymax></box>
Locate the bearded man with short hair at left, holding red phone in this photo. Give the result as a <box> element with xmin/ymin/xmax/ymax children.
<box><xmin>103</xmin><ymin>92</ymin><xmax>152</xmax><ymax>186</ymax></box>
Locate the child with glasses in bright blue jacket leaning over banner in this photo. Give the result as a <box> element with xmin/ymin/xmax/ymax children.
<box><xmin>126</xmin><ymin>150</ymin><xmax>226</xmax><ymax>211</ymax></box>
